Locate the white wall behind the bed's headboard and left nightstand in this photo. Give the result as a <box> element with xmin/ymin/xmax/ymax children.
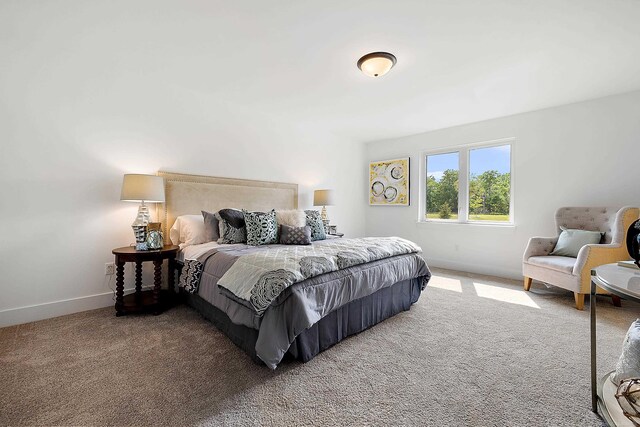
<box><xmin>0</xmin><ymin>11</ymin><xmax>366</xmax><ymax>326</ymax></box>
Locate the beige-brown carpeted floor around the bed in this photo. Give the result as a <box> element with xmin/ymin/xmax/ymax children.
<box><xmin>0</xmin><ymin>270</ymin><xmax>640</xmax><ymax>426</ymax></box>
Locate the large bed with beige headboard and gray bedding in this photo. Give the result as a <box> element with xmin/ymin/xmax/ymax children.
<box><xmin>158</xmin><ymin>172</ymin><xmax>431</xmax><ymax>369</ymax></box>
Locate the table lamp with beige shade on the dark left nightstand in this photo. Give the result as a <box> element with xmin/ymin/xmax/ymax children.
<box><xmin>120</xmin><ymin>174</ymin><xmax>164</xmax><ymax>251</ymax></box>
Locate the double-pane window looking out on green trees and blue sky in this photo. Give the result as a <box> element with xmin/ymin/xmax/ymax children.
<box><xmin>421</xmin><ymin>140</ymin><xmax>513</xmax><ymax>224</ymax></box>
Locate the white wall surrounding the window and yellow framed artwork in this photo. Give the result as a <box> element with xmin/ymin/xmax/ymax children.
<box><xmin>366</xmin><ymin>92</ymin><xmax>640</xmax><ymax>278</ymax></box>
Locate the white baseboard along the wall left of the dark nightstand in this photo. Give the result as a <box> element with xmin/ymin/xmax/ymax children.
<box><xmin>0</xmin><ymin>288</ymin><xmax>147</xmax><ymax>328</ymax></box>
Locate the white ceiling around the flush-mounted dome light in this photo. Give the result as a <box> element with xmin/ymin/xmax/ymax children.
<box><xmin>5</xmin><ymin>0</ymin><xmax>640</xmax><ymax>141</ymax></box>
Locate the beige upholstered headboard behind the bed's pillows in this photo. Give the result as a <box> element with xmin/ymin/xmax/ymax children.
<box><xmin>156</xmin><ymin>171</ymin><xmax>298</xmax><ymax>242</ymax></box>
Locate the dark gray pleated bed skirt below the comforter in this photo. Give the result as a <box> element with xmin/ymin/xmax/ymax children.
<box><xmin>186</xmin><ymin>278</ymin><xmax>422</xmax><ymax>364</ymax></box>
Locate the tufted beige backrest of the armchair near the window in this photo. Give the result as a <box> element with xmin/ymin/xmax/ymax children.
<box><xmin>556</xmin><ymin>206</ymin><xmax>640</xmax><ymax>243</ymax></box>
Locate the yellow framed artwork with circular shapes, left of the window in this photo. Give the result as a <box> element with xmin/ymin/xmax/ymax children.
<box><xmin>369</xmin><ymin>157</ymin><xmax>410</xmax><ymax>206</ymax></box>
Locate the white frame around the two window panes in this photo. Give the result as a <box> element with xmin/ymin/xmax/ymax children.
<box><xmin>418</xmin><ymin>137</ymin><xmax>516</xmax><ymax>227</ymax></box>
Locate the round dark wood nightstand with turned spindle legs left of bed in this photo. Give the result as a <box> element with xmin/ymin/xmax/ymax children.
<box><xmin>112</xmin><ymin>245</ymin><xmax>180</xmax><ymax>316</ymax></box>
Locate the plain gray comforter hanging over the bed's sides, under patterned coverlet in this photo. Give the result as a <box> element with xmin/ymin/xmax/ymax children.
<box><xmin>181</xmin><ymin>241</ymin><xmax>431</xmax><ymax>369</ymax></box>
